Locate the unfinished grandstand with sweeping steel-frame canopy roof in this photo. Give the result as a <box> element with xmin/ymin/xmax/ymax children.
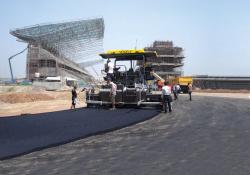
<box><xmin>10</xmin><ymin>18</ymin><xmax>104</xmax><ymax>81</ymax></box>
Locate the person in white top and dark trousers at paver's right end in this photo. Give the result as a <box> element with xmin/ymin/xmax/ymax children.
<box><xmin>162</xmin><ymin>81</ymin><xmax>172</xmax><ymax>113</ymax></box>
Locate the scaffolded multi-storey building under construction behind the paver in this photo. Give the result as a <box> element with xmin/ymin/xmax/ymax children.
<box><xmin>144</xmin><ymin>41</ymin><xmax>184</xmax><ymax>79</ymax></box>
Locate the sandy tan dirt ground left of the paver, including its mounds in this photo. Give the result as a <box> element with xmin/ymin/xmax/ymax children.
<box><xmin>0</xmin><ymin>91</ymin><xmax>86</xmax><ymax>117</ymax></box>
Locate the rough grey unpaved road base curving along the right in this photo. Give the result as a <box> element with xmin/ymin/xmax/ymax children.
<box><xmin>0</xmin><ymin>95</ymin><xmax>250</xmax><ymax>175</ymax></box>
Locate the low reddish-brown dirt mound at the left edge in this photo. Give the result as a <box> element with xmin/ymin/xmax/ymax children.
<box><xmin>0</xmin><ymin>93</ymin><xmax>54</xmax><ymax>103</ymax></box>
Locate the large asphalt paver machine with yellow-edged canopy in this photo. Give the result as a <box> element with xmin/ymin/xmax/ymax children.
<box><xmin>86</xmin><ymin>50</ymin><xmax>161</xmax><ymax>107</ymax></box>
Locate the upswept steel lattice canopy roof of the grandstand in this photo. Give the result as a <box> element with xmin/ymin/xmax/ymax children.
<box><xmin>10</xmin><ymin>18</ymin><xmax>104</xmax><ymax>63</ymax></box>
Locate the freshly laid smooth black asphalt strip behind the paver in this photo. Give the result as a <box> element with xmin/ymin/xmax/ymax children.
<box><xmin>0</xmin><ymin>108</ymin><xmax>159</xmax><ymax>160</ymax></box>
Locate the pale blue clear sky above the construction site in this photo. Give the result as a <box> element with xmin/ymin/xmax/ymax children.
<box><xmin>0</xmin><ymin>0</ymin><xmax>250</xmax><ymax>77</ymax></box>
